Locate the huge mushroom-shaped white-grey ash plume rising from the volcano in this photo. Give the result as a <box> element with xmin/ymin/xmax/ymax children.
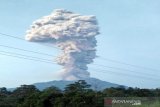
<box><xmin>26</xmin><ymin>9</ymin><xmax>99</xmax><ymax>80</ymax></box>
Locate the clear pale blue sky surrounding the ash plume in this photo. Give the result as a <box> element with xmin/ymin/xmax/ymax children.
<box><xmin>0</xmin><ymin>0</ymin><xmax>160</xmax><ymax>88</ymax></box>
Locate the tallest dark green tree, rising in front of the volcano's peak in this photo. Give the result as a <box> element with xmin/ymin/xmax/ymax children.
<box><xmin>64</xmin><ymin>80</ymin><xmax>99</xmax><ymax>107</ymax></box>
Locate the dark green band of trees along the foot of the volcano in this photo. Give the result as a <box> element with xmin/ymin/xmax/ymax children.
<box><xmin>0</xmin><ymin>80</ymin><xmax>160</xmax><ymax>107</ymax></box>
